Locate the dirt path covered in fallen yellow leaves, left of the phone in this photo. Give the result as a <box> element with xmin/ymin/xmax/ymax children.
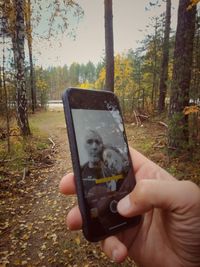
<box><xmin>0</xmin><ymin>113</ymin><xmax>133</xmax><ymax>267</ymax></box>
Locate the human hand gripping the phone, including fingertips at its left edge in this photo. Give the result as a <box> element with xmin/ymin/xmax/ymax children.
<box><xmin>60</xmin><ymin>149</ymin><xmax>200</xmax><ymax>267</ymax></box>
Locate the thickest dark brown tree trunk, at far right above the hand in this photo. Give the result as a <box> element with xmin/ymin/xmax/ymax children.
<box><xmin>169</xmin><ymin>0</ymin><xmax>196</xmax><ymax>152</ymax></box>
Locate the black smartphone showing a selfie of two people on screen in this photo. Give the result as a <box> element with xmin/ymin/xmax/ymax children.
<box><xmin>63</xmin><ymin>88</ymin><xmax>141</xmax><ymax>242</ymax></box>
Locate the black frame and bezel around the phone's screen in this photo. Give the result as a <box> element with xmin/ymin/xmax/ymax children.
<box><xmin>62</xmin><ymin>88</ymin><xmax>141</xmax><ymax>242</ymax></box>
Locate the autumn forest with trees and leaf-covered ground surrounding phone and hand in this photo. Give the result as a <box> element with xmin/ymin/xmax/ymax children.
<box><xmin>0</xmin><ymin>0</ymin><xmax>200</xmax><ymax>267</ymax></box>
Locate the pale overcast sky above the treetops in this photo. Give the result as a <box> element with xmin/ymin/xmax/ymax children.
<box><xmin>33</xmin><ymin>0</ymin><xmax>179</xmax><ymax>68</ymax></box>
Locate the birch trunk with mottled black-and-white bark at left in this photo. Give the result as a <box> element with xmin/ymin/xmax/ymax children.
<box><xmin>12</xmin><ymin>0</ymin><xmax>30</xmax><ymax>136</ymax></box>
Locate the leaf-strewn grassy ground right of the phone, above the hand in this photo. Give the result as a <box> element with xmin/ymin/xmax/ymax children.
<box><xmin>126</xmin><ymin>122</ymin><xmax>200</xmax><ymax>185</ymax></box>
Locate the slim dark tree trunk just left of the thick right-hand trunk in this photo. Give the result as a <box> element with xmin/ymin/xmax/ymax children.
<box><xmin>158</xmin><ymin>0</ymin><xmax>171</xmax><ymax>112</ymax></box>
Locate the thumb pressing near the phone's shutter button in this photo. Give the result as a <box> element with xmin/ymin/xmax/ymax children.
<box><xmin>117</xmin><ymin>179</ymin><xmax>200</xmax><ymax>217</ymax></box>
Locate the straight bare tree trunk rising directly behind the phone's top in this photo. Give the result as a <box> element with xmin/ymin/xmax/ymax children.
<box><xmin>104</xmin><ymin>0</ymin><xmax>114</xmax><ymax>92</ymax></box>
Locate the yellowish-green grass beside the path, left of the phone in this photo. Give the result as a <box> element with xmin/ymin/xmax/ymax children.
<box><xmin>0</xmin><ymin>112</ymin><xmax>55</xmax><ymax>176</ymax></box>
